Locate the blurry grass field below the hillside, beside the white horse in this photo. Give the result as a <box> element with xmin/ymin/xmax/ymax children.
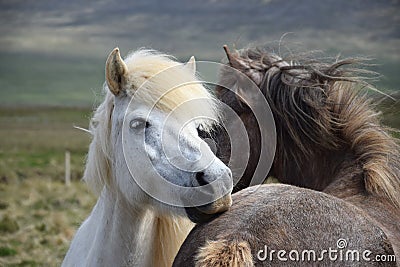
<box><xmin>0</xmin><ymin>101</ymin><xmax>400</xmax><ymax>266</ymax></box>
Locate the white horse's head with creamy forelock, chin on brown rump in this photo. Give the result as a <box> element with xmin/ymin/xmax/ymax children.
<box><xmin>84</xmin><ymin>48</ymin><xmax>233</xmax><ymax>222</ymax></box>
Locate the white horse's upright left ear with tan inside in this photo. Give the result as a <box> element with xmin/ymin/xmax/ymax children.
<box><xmin>106</xmin><ymin>47</ymin><xmax>128</xmax><ymax>95</ymax></box>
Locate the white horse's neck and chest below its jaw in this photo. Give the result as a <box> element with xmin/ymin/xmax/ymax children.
<box><xmin>63</xmin><ymin>189</ymin><xmax>192</xmax><ymax>266</ymax></box>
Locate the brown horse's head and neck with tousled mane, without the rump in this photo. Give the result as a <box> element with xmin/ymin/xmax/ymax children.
<box><xmin>216</xmin><ymin>49</ymin><xmax>400</xmax><ymax>208</ymax></box>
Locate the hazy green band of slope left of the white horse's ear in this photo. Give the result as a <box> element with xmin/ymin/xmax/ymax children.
<box><xmin>0</xmin><ymin>52</ymin><xmax>105</xmax><ymax>107</ymax></box>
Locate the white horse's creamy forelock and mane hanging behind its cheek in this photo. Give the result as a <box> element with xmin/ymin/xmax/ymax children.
<box><xmin>83</xmin><ymin>50</ymin><xmax>220</xmax><ymax>194</ymax></box>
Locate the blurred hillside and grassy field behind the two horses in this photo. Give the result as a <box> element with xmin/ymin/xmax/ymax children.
<box><xmin>0</xmin><ymin>0</ymin><xmax>400</xmax><ymax>266</ymax></box>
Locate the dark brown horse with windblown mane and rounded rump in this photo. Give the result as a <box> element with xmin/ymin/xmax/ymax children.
<box><xmin>174</xmin><ymin>47</ymin><xmax>400</xmax><ymax>266</ymax></box>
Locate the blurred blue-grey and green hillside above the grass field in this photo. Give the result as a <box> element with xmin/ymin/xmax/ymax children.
<box><xmin>0</xmin><ymin>0</ymin><xmax>400</xmax><ymax>106</ymax></box>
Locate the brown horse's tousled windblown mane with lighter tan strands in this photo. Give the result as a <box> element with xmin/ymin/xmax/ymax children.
<box><xmin>222</xmin><ymin>47</ymin><xmax>400</xmax><ymax>207</ymax></box>
